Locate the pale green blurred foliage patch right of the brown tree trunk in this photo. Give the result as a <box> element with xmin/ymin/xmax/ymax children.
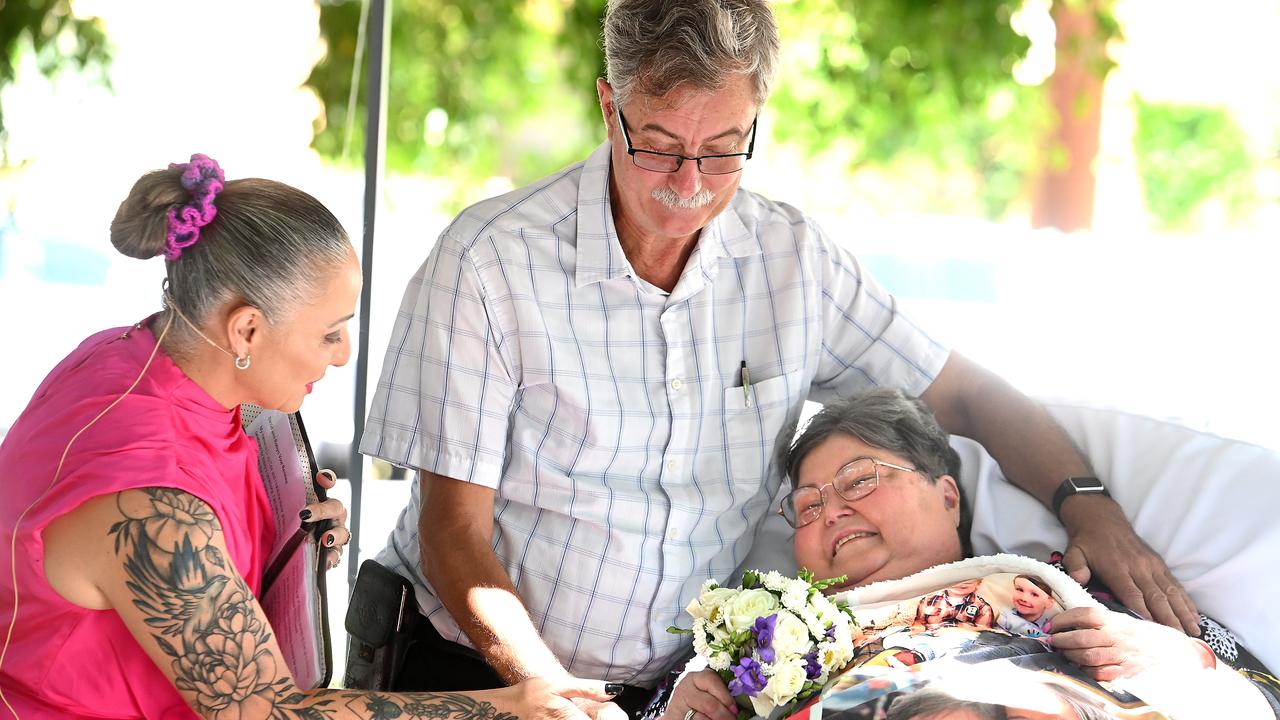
<box><xmin>1133</xmin><ymin>97</ymin><xmax>1256</xmax><ymax>229</ymax></box>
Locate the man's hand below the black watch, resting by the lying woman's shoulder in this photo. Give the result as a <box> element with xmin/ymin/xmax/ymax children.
<box><xmin>1062</xmin><ymin>495</ymin><xmax>1199</xmax><ymax>635</ymax></box>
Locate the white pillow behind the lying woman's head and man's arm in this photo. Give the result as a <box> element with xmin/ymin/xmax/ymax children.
<box><xmin>951</xmin><ymin>402</ymin><xmax>1280</xmax><ymax>670</ymax></box>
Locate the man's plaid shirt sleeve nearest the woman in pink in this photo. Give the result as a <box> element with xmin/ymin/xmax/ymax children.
<box><xmin>360</xmin><ymin>233</ymin><xmax>517</xmax><ymax>488</ymax></box>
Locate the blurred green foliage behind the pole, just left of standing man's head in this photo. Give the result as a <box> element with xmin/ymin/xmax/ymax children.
<box><xmin>308</xmin><ymin>0</ymin><xmax>604</xmax><ymax>181</ymax></box>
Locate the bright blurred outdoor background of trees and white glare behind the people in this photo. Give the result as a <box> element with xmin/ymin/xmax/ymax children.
<box><xmin>0</xmin><ymin>0</ymin><xmax>1280</xmax><ymax>442</ymax></box>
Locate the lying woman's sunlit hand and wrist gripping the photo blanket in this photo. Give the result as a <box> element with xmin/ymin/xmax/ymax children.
<box><xmin>1050</xmin><ymin>607</ymin><xmax>1211</xmax><ymax>680</ymax></box>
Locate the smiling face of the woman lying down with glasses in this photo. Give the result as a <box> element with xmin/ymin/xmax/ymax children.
<box><xmin>795</xmin><ymin>433</ymin><xmax>961</xmax><ymax>591</ymax></box>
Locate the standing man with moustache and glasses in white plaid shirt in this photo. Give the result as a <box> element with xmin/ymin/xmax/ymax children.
<box><xmin>361</xmin><ymin>0</ymin><xmax>1189</xmax><ymax>712</ymax></box>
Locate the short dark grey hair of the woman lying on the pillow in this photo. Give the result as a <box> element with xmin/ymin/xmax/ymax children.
<box><xmin>778</xmin><ymin>388</ymin><xmax>973</xmax><ymax>557</ymax></box>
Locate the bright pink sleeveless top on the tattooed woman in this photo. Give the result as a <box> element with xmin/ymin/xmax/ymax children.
<box><xmin>0</xmin><ymin>320</ymin><xmax>274</xmax><ymax>720</ymax></box>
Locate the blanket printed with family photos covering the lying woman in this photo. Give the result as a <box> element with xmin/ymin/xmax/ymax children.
<box><xmin>797</xmin><ymin>562</ymin><xmax>1165</xmax><ymax>720</ymax></box>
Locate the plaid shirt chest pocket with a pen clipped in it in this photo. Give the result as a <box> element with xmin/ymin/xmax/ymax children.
<box><xmin>724</xmin><ymin>370</ymin><xmax>804</xmax><ymax>486</ymax></box>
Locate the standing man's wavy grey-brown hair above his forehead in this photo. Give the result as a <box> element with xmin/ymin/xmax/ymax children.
<box><xmin>604</xmin><ymin>0</ymin><xmax>778</xmax><ymax>106</ymax></box>
